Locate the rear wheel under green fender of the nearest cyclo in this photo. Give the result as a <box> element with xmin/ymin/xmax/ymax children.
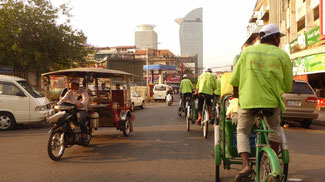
<box><xmin>259</xmin><ymin>152</ymin><xmax>281</xmax><ymax>182</ymax></box>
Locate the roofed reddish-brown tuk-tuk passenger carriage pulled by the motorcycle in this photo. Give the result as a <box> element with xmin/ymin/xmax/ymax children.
<box><xmin>42</xmin><ymin>68</ymin><xmax>135</xmax><ymax>137</ymax></box>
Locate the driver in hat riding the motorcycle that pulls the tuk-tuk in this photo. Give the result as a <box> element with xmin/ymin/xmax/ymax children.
<box><xmin>57</xmin><ymin>78</ymin><xmax>89</xmax><ymax>142</ymax></box>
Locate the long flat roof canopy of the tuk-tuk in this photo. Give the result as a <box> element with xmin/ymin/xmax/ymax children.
<box><xmin>42</xmin><ymin>68</ymin><xmax>132</xmax><ymax>78</ymax></box>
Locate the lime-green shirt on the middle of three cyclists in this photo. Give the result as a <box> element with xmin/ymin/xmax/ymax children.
<box><xmin>196</xmin><ymin>72</ymin><xmax>218</xmax><ymax>95</ymax></box>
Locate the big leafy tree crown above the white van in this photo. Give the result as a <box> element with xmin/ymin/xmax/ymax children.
<box><xmin>0</xmin><ymin>0</ymin><xmax>88</xmax><ymax>72</ymax></box>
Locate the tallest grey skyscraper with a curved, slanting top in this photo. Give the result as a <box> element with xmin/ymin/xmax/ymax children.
<box><xmin>175</xmin><ymin>8</ymin><xmax>203</xmax><ymax>73</ymax></box>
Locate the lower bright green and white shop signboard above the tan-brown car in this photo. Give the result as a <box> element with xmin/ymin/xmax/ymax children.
<box><xmin>293</xmin><ymin>53</ymin><xmax>325</xmax><ymax>75</ymax></box>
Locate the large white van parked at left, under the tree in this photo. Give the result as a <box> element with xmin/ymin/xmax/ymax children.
<box><xmin>0</xmin><ymin>75</ymin><xmax>52</xmax><ymax>130</ymax></box>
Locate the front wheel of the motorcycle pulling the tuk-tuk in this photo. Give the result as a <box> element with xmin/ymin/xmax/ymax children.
<box><xmin>47</xmin><ymin>131</ymin><xmax>65</xmax><ymax>161</ymax></box>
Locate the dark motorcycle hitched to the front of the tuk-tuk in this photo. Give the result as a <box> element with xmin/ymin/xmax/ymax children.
<box><xmin>47</xmin><ymin>103</ymin><xmax>99</xmax><ymax>161</ymax></box>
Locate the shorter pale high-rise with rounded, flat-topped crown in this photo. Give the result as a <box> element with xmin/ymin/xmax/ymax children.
<box><xmin>135</xmin><ymin>24</ymin><xmax>158</xmax><ymax>49</ymax></box>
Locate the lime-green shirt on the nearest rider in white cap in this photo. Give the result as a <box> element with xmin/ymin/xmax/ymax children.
<box><xmin>230</xmin><ymin>44</ymin><xmax>292</xmax><ymax>111</ymax></box>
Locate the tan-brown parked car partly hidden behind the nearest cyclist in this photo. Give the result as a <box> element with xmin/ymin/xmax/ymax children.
<box><xmin>282</xmin><ymin>80</ymin><xmax>318</xmax><ymax>128</ymax></box>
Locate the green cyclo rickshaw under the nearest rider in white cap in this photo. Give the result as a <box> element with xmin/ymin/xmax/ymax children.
<box><xmin>214</xmin><ymin>73</ymin><xmax>290</xmax><ymax>182</ymax></box>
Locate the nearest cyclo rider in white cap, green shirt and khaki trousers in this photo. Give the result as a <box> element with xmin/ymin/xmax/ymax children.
<box><xmin>230</xmin><ymin>24</ymin><xmax>292</xmax><ymax>181</ymax></box>
